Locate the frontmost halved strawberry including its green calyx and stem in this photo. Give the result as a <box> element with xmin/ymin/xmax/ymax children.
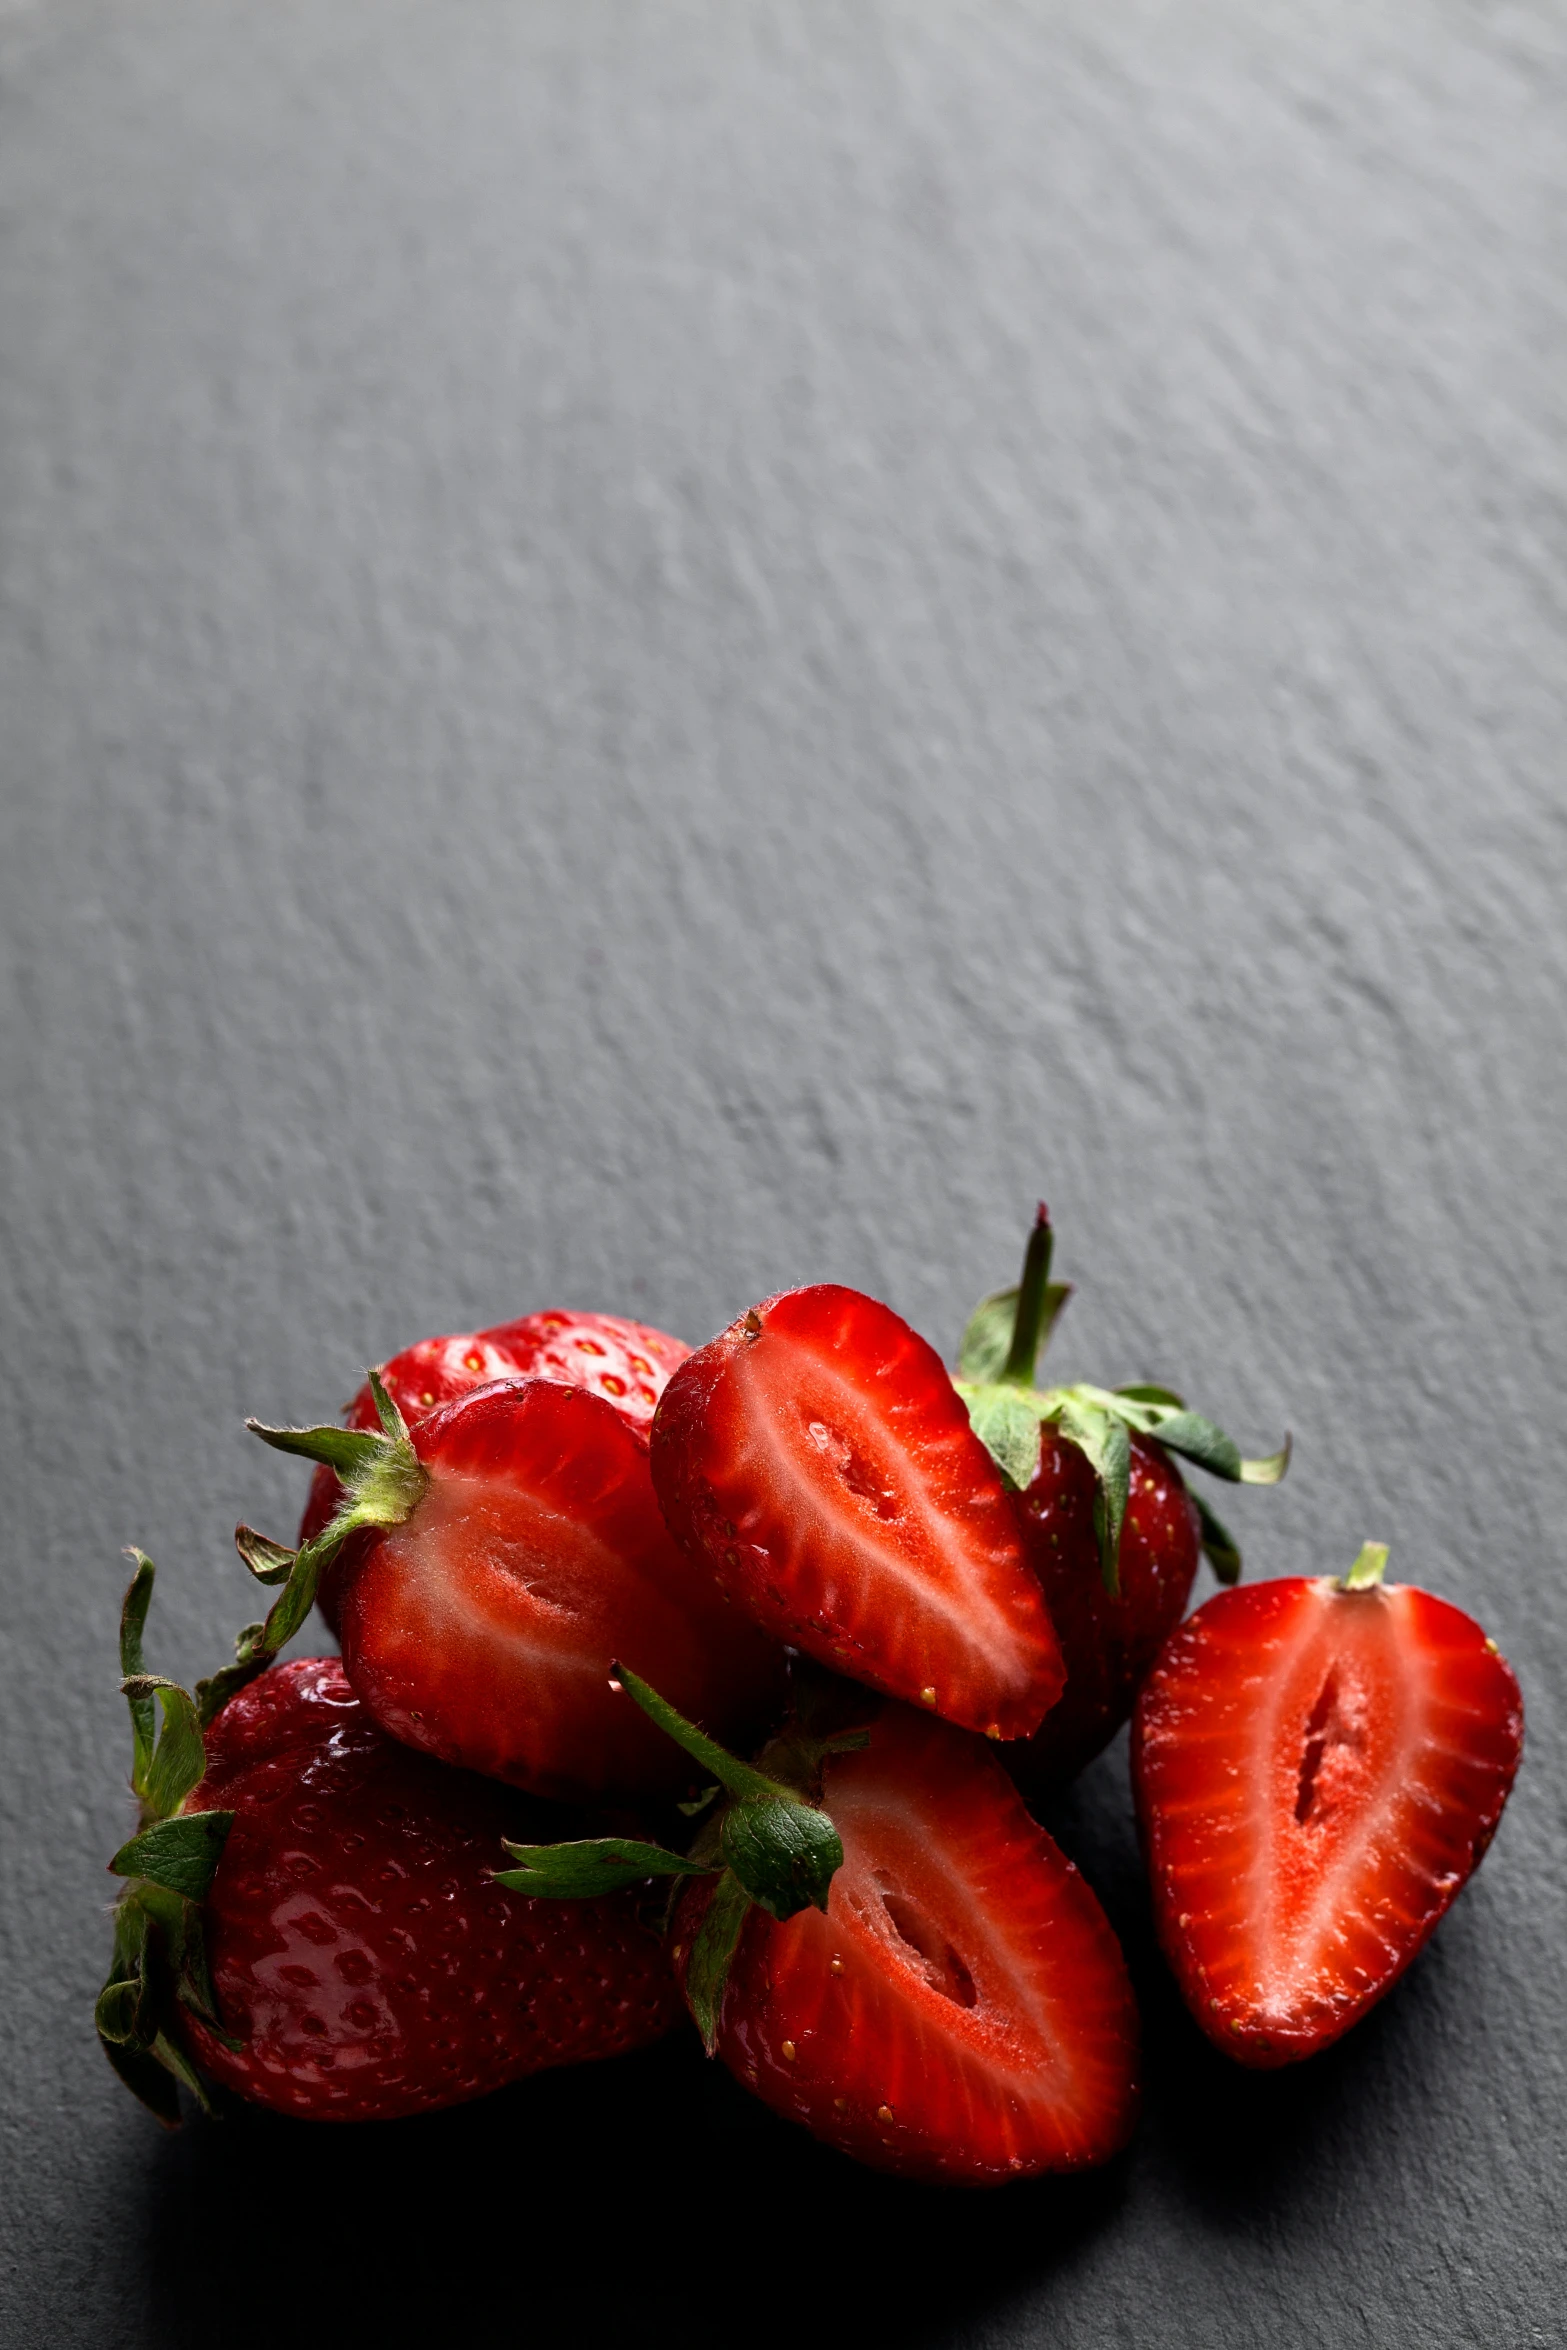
<box><xmin>503</xmin><ymin>1673</ymin><xmax>1137</xmax><ymax>2186</ymax></box>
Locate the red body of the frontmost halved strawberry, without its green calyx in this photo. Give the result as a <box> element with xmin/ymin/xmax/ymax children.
<box><xmin>674</xmin><ymin>1706</ymin><xmax>1137</xmax><ymax>2186</ymax></box>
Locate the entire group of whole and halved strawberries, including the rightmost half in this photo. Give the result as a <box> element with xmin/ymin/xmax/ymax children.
<box><xmin>96</xmin><ymin>1208</ymin><xmax>1522</xmax><ymax>2183</ymax></box>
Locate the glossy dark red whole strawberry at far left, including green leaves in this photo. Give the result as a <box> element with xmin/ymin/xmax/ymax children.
<box><xmin>99</xmin><ymin>1560</ymin><xmax>681</xmax><ymax>2122</ymax></box>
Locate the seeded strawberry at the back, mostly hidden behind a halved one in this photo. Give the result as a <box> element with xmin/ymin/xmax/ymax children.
<box><xmin>298</xmin><ymin>1309</ymin><xmax>691</xmax><ymax>1631</ymax></box>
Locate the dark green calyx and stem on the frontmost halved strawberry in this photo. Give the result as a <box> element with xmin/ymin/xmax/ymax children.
<box><xmin>493</xmin><ymin>1664</ymin><xmax>874</xmax><ymax>2056</ymax></box>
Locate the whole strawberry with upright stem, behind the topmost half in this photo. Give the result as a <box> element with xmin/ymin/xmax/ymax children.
<box><xmin>956</xmin><ymin>1206</ymin><xmax>1290</xmax><ymax>1793</ymax></box>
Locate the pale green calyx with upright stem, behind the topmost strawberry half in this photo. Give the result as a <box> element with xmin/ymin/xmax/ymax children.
<box><xmin>954</xmin><ymin>1201</ymin><xmax>1290</xmax><ymax>1596</ymax></box>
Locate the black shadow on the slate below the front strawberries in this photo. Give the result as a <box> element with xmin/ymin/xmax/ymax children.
<box><xmin>148</xmin><ymin>2035</ymin><xmax>1125</xmax><ymax>2350</ymax></box>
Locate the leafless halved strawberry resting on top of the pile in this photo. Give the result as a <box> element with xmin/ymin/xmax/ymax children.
<box><xmin>651</xmin><ymin>1283</ymin><xmax>1064</xmax><ymax>1739</ymax></box>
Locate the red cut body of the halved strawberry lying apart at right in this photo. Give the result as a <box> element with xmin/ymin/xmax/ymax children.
<box><xmin>1132</xmin><ymin>1577</ymin><xmax>1522</xmax><ymax>2066</ymax></box>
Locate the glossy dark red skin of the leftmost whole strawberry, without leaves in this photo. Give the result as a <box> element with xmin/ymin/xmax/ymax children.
<box><xmin>183</xmin><ymin>1657</ymin><xmax>681</xmax><ymax>2122</ymax></box>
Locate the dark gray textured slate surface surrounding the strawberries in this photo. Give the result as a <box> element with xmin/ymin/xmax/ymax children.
<box><xmin>0</xmin><ymin>0</ymin><xmax>1567</xmax><ymax>2350</ymax></box>
